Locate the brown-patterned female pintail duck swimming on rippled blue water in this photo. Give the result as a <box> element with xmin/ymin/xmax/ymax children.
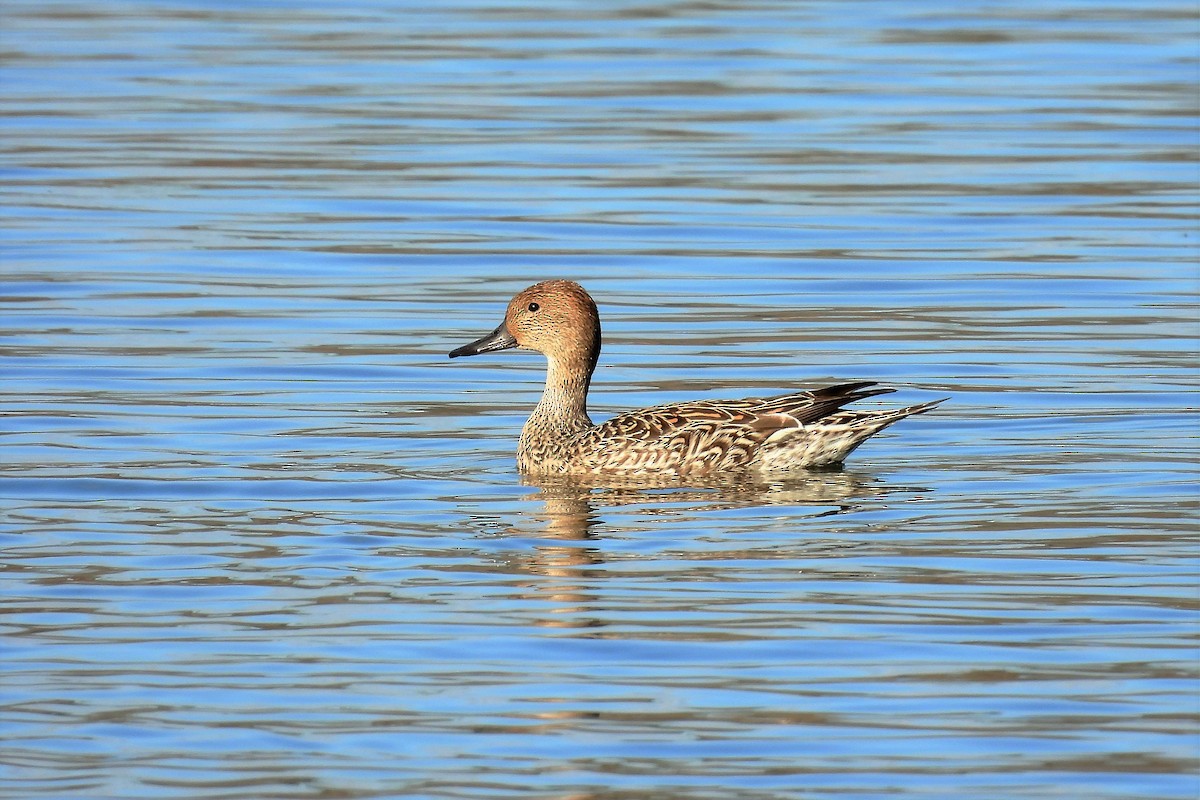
<box><xmin>450</xmin><ymin>281</ymin><xmax>942</xmax><ymax>475</ymax></box>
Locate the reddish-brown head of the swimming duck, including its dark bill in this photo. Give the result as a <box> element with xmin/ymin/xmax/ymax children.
<box><xmin>450</xmin><ymin>281</ymin><xmax>600</xmax><ymax>383</ymax></box>
